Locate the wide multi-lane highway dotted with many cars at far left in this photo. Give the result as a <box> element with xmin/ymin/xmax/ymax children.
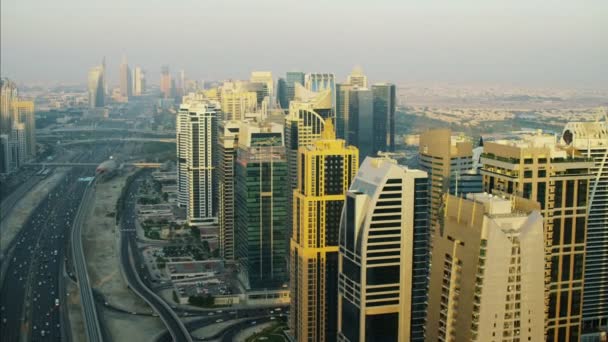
<box><xmin>0</xmin><ymin>148</ymin><xmax>109</xmax><ymax>341</ymax></box>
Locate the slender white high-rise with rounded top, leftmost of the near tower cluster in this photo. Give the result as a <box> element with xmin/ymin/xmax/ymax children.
<box><xmin>176</xmin><ymin>93</ymin><xmax>220</xmax><ymax>225</ymax></box>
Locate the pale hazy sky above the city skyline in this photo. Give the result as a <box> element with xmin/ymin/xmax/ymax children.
<box><xmin>0</xmin><ymin>0</ymin><xmax>608</xmax><ymax>88</ymax></box>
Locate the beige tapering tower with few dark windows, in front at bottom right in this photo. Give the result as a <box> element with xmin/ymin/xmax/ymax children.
<box><xmin>426</xmin><ymin>193</ymin><xmax>545</xmax><ymax>341</ymax></box>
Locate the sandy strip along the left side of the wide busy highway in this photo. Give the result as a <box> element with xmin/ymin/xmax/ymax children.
<box><xmin>0</xmin><ymin>168</ymin><xmax>67</xmax><ymax>253</ymax></box>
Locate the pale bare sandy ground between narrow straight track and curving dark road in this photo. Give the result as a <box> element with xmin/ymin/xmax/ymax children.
<box><xmin>83</xmin><ymin>174</ymin><xmax>164</xmax><ymax>341</ymax></box>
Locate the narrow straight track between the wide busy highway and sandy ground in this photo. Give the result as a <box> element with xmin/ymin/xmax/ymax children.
<box><xmin>71</xmin><ymin>181</ymin><xmax>103</xmax><ymax>342</ymax></box>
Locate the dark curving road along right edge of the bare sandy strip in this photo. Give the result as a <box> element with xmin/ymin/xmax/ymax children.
<box><xmin>120</xmin><ymin>172</ymin><xmax>192</xmax><ymax>342</ymax></box>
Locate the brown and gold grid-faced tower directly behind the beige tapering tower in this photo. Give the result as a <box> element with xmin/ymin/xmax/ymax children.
<box><xmin>481</xmin><ymin>132</ymin><xmax>595</xmax><ymax>341</ymax></box>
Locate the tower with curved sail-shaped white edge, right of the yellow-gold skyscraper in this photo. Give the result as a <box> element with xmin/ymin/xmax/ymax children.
<box><xmin>340</xmin><ymin>157</ymin><xmax>428</xmax><ymax>342</ymax></box>
